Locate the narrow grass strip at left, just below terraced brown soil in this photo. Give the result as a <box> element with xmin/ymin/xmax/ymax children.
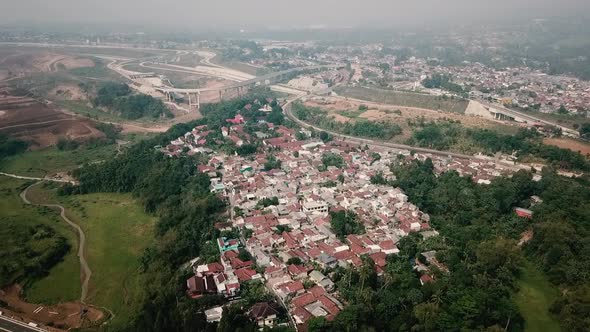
<box><xmin>0</xmin><ymin>144</ymin><xmax>117</xmax><ymax>177</ymax></box>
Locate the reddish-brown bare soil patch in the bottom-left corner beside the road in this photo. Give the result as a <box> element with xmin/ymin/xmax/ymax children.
<box><xmin>0</xmin><ymin>285</ymin><xmax>105</xmax><ymax>330</ymax></box>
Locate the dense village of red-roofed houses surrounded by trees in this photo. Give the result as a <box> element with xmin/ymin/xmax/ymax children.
<box><xmin>161</xmin><ymin>100</ymin><xmax>530</xmax><ymax>330</ymax></box>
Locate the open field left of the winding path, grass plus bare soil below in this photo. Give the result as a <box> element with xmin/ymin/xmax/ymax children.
<box><xmin>0</xmin><ymin>176</ymin><xmax>104</xmax><ymax>328</ymax></box>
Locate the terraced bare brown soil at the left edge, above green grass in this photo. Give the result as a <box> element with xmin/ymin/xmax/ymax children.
<box><xmin>0</xmin><ymin>94</ymin><xmax>104</xmax><ymax>149</ymax></box>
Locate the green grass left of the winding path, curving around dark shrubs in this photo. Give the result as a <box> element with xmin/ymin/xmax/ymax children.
<box><xmin>0</xmin><ymin>176</ymin><xmax>80</xmax><ymax>303</ymax></box>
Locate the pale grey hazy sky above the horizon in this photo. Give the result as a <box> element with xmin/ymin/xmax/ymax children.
<box><xmin>0</xmin><ymin>0</ymin><xmax>590</xmax><ymax>30</ymax></box>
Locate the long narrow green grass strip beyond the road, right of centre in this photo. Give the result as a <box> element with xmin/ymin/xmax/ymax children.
<box><xmin>335</xmin><ymin>87</ymin><xmax>468</xmax><ymax>113</ymax></box>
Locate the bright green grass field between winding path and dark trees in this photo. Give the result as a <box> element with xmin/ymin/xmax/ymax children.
<box><xmin>30</xmin><ymin>185</ymin><xmax>156</xmax><ymax>330</ymax></box>
